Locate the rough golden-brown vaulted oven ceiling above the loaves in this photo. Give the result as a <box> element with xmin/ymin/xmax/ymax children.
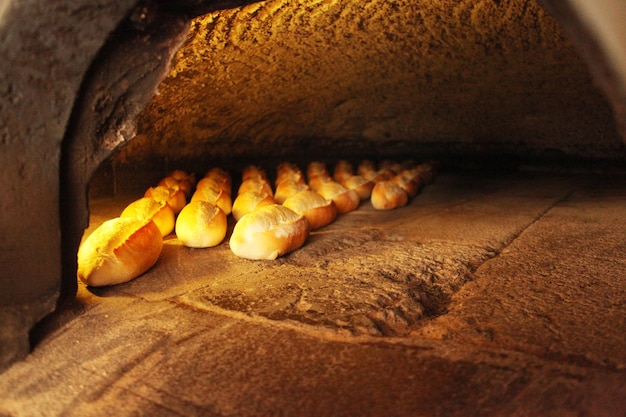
<box><xmin>116</xmin><ymin>0</ymin><xmax>624</xmax><ymax>164</ymax></box>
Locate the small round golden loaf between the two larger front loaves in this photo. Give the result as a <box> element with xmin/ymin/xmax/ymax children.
<box><xmin>176</xmin><ymin>200</ymin><xmax>228</xmax><ymax>248</ymax></box>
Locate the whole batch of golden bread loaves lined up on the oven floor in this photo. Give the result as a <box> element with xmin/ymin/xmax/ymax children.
<box><xmin>78</xmin><ymin>161</ymin><xmax>436</xmax><ymax>286</ymax></box>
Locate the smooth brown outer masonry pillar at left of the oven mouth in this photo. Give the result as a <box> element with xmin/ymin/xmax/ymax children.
<box><xmin>0</xmin><ymin>0</ymin><xmax>134</xmax><ymax>370</ymax></box>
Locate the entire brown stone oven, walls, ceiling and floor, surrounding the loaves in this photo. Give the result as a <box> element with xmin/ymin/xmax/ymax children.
<box><xmin>0</xmin><ymin>0</ymin><xmax>626</xmax><ymax>416</ymax></box>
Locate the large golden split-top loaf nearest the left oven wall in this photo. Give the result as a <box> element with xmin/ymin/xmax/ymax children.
<box><xmin>77</xmin><ymin>217</ymin><xmax>163</xmax><ymax>287</ymax></box>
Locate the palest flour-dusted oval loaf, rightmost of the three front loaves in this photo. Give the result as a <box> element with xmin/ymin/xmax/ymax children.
<box><xmin>230</xmin><ymin>204</ymin><xmax>309</xmax><ymax>260</ymax></box>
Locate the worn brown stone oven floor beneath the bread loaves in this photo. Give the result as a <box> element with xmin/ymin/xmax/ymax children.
<box><xmin>0</xmin><ymin>171</ymin><xmax>626</xmax><ymax>417</ymax></box>
